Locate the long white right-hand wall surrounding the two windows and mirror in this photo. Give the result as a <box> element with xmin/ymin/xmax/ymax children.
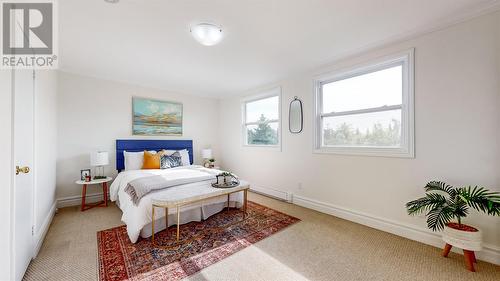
<box><xmin>219</xmin><ymin>12</ymin><xmax>500</xmax><ymax>263</ymax></box>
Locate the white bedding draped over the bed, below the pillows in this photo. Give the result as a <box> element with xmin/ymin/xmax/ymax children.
<box><xmin>109</xmin><ymin>165</ymin><xmax>243</xmax><ymax>243</ymax></box>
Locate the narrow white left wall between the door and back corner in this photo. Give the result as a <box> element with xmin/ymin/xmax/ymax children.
<box><xmin>33</xmin><ymin>70</ymin><xmax>57</xmax><ymax>253</ymax></box>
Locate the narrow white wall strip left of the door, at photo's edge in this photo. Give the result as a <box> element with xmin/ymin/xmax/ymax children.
<box><xmin>0</xmin><ymin>70</ymin><xmax>13</xmax><ymax>280</ymax></box>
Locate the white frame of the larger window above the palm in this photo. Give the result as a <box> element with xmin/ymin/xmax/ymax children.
<box><xmin>313</xmin><ymin>48</ymin><xmax>415</xmax><ymax>158</ymax></box>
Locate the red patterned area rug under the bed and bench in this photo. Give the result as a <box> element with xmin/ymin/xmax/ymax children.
<box><xmin>97</xmin><ymin>202</ymin><xmax>299</xmax><ymax>281</ymax></box>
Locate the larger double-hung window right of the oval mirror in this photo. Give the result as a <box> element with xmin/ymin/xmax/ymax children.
<box><xmin>314</xmin><ymin>50</ymin><xmax>414</xmax><ymax>157</ymax></box>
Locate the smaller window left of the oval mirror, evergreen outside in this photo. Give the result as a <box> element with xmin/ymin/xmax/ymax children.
<box><xmin>242</xmin><ymin>88</ymin><xmax>281</xmax><ymax>147</ymax></box>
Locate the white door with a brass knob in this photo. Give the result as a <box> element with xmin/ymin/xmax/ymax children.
<box><xmin>13</xmin><ymin>70</ymin><xmax>34</xmax><ymax>280</ymax></box>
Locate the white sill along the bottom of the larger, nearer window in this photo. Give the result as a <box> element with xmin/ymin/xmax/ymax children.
<box><xmin>313</xmin><ymin>147</ymin><xmax>415</xmax><ymax>158</ymax></box>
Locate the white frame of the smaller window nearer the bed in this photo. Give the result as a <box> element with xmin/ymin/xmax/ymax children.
<box><xmin>241</xmin><ymin>86</ymin><xmax>282</xmax><ymax>151</ymax></box>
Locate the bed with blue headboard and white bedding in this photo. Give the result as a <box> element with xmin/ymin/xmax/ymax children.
<box><xmin>110</xmin><ymin>140</ymin><xmax>243</xmax><ymax>243</ymax></box>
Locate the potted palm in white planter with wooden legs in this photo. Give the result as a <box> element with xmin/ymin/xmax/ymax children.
<box><xmin>406</xmin><ymin>181</ymin><xmax>500</xmax><ymax>271</ymax></box>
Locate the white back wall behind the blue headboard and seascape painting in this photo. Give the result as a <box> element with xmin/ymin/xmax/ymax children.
<box><xmin>57</xmin><ymin>72</ymin><xmax>218</xmax><ymax>198</ymax></box>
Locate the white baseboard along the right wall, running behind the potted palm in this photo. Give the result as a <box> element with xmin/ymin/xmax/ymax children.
<box><xmin>293</xmin><ymin>195</ymin><xmax>500</xmax><ymax>265</ymax></box>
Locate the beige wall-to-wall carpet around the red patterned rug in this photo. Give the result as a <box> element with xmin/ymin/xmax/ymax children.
<box><xmin>24</xmin><ymin>194</ymin><xmax>500</xmax><ymax>281</ymax></box>
